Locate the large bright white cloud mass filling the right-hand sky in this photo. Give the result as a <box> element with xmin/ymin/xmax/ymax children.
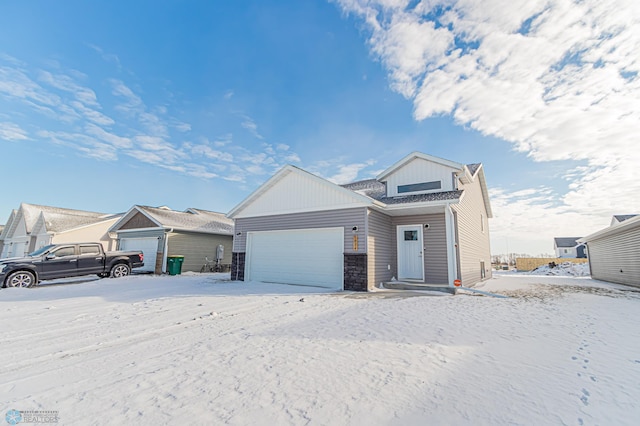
<box><xmin>336</xmin><ymin>0</ymin><xmax>640</xmax><ymax>253</ymax></box>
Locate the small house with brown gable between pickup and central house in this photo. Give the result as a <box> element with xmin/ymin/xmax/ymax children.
<box><xmin>110</xmin><ymin>206</ymin><xmax>233</xmax><ymax>274</ymax></box>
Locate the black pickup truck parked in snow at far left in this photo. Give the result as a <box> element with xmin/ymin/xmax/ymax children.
<box><xmin>0</xmin><ymin>243</ymin><xmax>144</xmax><ymax>287</ymax></box>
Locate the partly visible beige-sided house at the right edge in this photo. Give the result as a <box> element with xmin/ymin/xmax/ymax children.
<box><xmin>580</xmin><ymin>215</ymin><xmax>640</xmax><ymax>287</ymax></box>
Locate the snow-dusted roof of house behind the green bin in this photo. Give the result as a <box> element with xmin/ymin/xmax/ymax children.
<box><xmin>110</xmin><ymin>205</ymin><xmax>233</xmax><ymax>235</ymax></box>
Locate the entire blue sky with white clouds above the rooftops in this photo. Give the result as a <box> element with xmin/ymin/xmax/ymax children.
<box><xmin>0</xmin><ymin>0</ymin><xmax>640</xmax><ymax>255</ymax></box>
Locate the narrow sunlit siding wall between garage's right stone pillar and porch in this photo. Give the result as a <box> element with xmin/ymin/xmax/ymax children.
<box><xmin>367</xmin><ymin>210</ymin><xmax>396</xmax><ymax>289</ymax></box>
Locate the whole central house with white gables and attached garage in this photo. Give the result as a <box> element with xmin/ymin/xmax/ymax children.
<box><xmin>227</xmin><ymin>152</ymin><xmax>491</xmax><ymax>291</ymax></box>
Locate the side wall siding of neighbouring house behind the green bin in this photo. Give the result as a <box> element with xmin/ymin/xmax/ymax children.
<box><xmin>167</xmin><ymin>232</ymin><xmax>233</xmax><ymax>272</ymax></box>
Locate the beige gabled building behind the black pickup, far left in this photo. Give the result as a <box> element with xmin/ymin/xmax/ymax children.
<box><xmin>0</xmin><ymin>203</ymin><xmax>120</xmax><ymax>258</ymax></box>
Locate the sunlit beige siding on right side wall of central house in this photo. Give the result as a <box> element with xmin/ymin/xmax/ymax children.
<box><xmin>452</xmin><ymin>178</ymin><xmax>491</xmax><ymax>287</ymax></box>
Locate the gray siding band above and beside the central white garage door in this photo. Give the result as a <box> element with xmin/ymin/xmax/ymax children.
<box><xmin>233</xmin><ymin>207</ymin><xmax>367</xmax><ymax>253</ymax></box>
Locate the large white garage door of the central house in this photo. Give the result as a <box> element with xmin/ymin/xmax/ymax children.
<box><xmin>245</xmin><ymin>228</ymin><xmax>344</xmax><ymax>288</ymax></box>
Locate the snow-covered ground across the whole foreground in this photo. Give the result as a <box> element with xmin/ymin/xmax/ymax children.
<box><xmin>0</xmin><ymin>273</ymin><xmax>640</xmax><ymax>426</ymax></box>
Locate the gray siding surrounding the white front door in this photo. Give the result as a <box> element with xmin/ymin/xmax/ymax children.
<box><xmin>391</xmin><ymin>213</ymin><xmax>449</xmax><ymax>285</ymax></box>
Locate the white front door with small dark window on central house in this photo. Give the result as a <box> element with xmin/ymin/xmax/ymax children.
<box><xmin>397</xmin><ymin>225</ymin><xmax>424</xmax><ymax>281</ymax></box>
